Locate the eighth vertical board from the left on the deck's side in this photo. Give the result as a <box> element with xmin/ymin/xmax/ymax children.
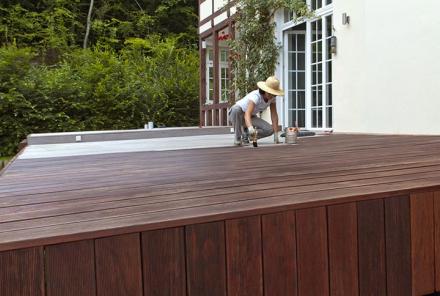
<box><xmin>296</xmin><ymin>207</ymin><xmax>329</xmax><ymax>296</ymax></box>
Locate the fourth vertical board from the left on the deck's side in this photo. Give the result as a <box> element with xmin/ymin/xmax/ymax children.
<box><xmin>142</xmin><ymin>227</ymin><xmax>186</xmax><ymax>296</ymax></box>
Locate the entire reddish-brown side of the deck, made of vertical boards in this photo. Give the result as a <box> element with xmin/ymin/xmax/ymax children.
<box><xmin>0</xmin><ymin>192</ymin><xmax>440</xmax><ymax>296</ymax></box>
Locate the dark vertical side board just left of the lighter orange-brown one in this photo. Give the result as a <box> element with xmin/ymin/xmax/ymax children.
<box><xmin>385</xmin><ymin>196</ymin><xmax>411</xmax><ymax>296</ymax></box>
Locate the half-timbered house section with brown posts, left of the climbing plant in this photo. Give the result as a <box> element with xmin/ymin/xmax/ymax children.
<box><xmin>199</xmin><ymin>0</ymin><xmax>235</xmax><ymax>126</ymax></box>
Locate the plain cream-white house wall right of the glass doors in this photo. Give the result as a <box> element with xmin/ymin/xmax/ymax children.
<box><xmin>333</xmin><ymin>0</ymin><xmax>440</xmax><ymax>134</ymax></box>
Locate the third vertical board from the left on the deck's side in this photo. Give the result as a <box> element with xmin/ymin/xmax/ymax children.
<box><xmin>95</xmin><ymin>233</ymin><xmax>142</xmax><ymax>296</ymax></box>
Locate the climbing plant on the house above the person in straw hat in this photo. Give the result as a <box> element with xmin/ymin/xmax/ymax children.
<box><xmin>230</xmin><ymin>0</ymin><xmax>311</xmax><ymax>103</ymax></box>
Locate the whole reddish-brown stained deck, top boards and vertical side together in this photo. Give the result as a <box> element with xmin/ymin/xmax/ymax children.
<box><xmin>0</xmin><ymin>135</ymin><xmax>440</xmax><ymax>296</ymax></box>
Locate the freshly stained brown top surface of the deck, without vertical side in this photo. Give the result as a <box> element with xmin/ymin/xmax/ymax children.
<box><xmin>0</xmin><ymin>135</ymin><xmax>440</xmax><ymax>251</ymax></box>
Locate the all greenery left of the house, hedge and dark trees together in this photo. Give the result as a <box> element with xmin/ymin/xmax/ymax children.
<box><xmin>0</xmin><ymin>0</ymin><xmax>199</xmax><ymax>155</ymax></box>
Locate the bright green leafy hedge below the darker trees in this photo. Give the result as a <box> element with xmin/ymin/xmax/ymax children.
<box><xmin>0</xmin><ymin>36</ymin><xmax>199</xmax><ymax>155</ymax></box>
